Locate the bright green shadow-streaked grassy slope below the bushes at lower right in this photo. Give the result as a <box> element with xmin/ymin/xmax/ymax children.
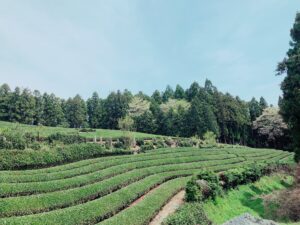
<box><xmin>204</xmin><ymin>174</ymin><xmax>292</xmax><ymax>224</ymax></box>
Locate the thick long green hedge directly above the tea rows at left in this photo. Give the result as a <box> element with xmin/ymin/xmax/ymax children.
<box><xmin>0</xmin><ymin>143</ymin><xmax>129</xmax><ymax>170</ymax></box>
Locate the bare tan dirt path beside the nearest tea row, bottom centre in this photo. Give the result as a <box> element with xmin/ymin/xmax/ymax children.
<box><xmin>149</xmin><ymin>191</ymin><xmax>185</xmax><ymax>225</ymax></box>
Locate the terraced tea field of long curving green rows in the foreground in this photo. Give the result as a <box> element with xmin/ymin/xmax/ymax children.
<box><xmin>0</xmin><ymin>147</ymin><xmax>293</xmax><ymax>225</ymax></box>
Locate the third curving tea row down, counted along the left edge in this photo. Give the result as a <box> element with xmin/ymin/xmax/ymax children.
<box><xmin>0</xmin><ymin>157</ymin><xmax>243</xmax><ymax>217</ymax></box>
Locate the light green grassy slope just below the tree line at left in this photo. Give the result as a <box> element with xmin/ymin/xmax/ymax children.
<box><xmin>0</xmin><ymin>121</ymin><xmax>162</xmax><ymax>138</ymax></box>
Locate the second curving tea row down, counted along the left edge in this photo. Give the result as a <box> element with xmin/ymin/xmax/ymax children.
<box><xmin>0</xmin><ymin>155</ymin><xmax>243</xmax><ymax>196</ymax></box>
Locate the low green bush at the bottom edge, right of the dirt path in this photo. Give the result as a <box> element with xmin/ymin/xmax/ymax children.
<box><xmin>163</xmin><ymin>203</ymin><xmax>212</xmax><ymax>225</ymax></box>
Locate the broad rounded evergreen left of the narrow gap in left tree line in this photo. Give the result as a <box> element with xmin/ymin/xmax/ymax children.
<box><xmin>65</xmin><ymin>95</ymin><xmax>87</xmax><ymax>128</ymax></box>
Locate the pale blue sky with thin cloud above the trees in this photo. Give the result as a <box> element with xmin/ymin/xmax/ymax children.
<box><xmin>0</xmin><ymin>0</ymin><xmax>300</xmax><ymax>105</ymax></box>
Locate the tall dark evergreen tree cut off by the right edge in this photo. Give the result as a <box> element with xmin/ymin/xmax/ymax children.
<box><xmin>277</xmin><ymin>13</ymin><xmax>300</xmax><ymax>161</ymax></box>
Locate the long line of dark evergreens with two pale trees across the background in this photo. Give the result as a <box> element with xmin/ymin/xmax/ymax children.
<box><xmin>0</xmin><ymin>80</ymin><xmax>268</xmax><ymax>144</ymax></box>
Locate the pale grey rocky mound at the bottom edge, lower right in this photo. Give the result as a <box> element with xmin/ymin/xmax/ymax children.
<box><xmin>223</xmin><ymin>213</ymin><xmax>277</xmax><ymax>225</ymax></box>
